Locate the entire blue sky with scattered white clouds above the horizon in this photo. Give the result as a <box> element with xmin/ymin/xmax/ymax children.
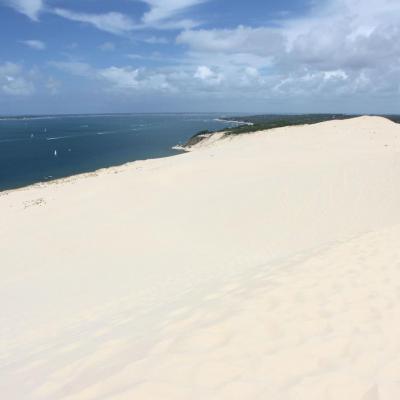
<box><xmin>0</xmin><ymin>0</ymin><xmax>400</xmax><ymax>115</ymax></box>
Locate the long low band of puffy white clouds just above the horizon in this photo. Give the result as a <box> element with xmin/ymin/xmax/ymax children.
<box><xmin>48</xmin><ymin>54</ymin><xmax>400</xmax><ymax>104</ymax></box>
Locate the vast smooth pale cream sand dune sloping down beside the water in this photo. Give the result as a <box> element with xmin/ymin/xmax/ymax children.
<box><xmin>0</xmin><ymin>117</ymin><xmax>400</xmax><ymax>400</ymax></box>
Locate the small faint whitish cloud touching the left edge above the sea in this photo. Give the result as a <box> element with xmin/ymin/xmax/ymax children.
<box><xmin>0</xmin><ymin>62</ymin><xmax>35</xmax><ymax>96</ymax></box>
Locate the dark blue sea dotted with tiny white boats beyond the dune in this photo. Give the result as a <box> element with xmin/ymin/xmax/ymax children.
<box><xmin>0</xmin><ymin>114</ymin><xmax>234</xmax><ymax>191</ymax></box>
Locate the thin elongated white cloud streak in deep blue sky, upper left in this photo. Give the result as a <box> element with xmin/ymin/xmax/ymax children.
<box><xmin>52</xmin><ymin>8</ymin><xmax>135</xmax><ymax>35</ymax></box>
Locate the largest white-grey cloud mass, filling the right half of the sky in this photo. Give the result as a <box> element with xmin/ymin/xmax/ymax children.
<box><xmin>177</xmin><ymin>0</ymin><xmax>400</xmax><ymax>100</ymax></box>
